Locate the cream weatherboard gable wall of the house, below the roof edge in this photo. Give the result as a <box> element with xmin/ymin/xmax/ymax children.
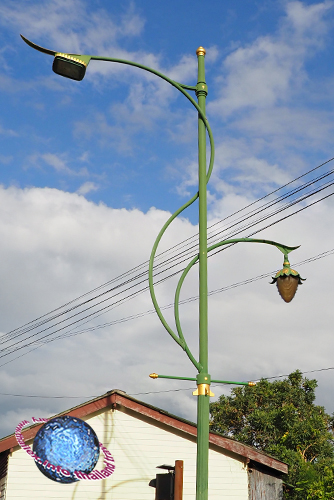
<box><xmin>6</xmin><ymin>410</ymin><xmax>248</xmax><ymax>500</ymax></box>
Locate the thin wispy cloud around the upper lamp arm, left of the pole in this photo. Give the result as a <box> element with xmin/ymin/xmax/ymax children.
<box><xmin>0</xmin><ymin>0</ymin><xmax>209</xmax><ymax>145</ymax></box>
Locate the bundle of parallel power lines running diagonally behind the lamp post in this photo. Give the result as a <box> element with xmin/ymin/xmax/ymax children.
<box><xmin>0</xmin><ymin>158</ymin><xmax>334</xmax><ymax>357</ymax></box>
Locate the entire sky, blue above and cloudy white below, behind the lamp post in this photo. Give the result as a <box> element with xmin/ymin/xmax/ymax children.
<box><xmin>0</xmin><ymin>0</ymin><xmax>334</xmax><ymax>442</ymax></box>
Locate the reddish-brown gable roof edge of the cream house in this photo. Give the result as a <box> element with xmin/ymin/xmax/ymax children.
<box><xmin>0</xmin><ymin>389</ymin><xmax>288</xmax><ymax>474</ymax></box>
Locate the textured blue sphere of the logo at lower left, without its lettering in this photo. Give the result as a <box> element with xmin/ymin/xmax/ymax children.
<box><xmin>33</xmin><ymin>415</ymin><xmax>100</xmax><ymax>483</ymax></box>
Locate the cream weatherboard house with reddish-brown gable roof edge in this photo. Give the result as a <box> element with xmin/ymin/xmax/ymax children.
<box><xmin>0</xmin><ymin>390</ymin><xmax>288</xmax><ymax>500</ymax></box>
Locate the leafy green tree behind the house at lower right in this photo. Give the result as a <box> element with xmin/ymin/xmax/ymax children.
<box><xmin>210</xmin><ymin>370</ymin><xmax>334</xmax><ymax>500</ymax></box>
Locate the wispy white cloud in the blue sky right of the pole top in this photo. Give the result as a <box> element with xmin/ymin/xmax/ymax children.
<box><xmin>193</xmin><ymin>1</ymin><xmax>334</xmax><ymax>214</ymax></box>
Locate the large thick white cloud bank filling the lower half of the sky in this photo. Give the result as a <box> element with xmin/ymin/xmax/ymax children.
<box><xmin>0</xmin><ymin>188</ymin><xmax>334</xmax><ymax>433</ymax></box>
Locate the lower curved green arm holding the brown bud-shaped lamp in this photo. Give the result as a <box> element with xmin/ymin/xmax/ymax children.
<box><xmin>174</xmin><ymin>238</ymin><xmax>299</xmax><ymax>371</ymax></box>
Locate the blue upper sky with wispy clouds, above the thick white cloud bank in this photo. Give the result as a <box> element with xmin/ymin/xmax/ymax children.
<box><xmin>0</xmin><ymin>1</ymin><xmax>333</xmax><ymax>215</ymax></box>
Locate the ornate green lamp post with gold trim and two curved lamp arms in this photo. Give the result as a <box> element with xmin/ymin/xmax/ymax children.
<box><xmin>21</xmin><ymin>35</ymin><xmax>302</xmax><ymax>500</ymax></box>
